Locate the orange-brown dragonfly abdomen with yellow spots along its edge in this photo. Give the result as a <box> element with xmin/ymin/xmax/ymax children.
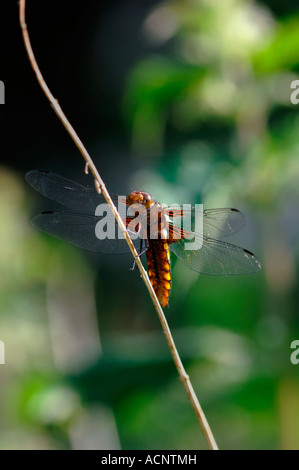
<box><xmin>146</xmin><ymin>239</ymin><xmax>171</xmax><ymax>307</ymax></box>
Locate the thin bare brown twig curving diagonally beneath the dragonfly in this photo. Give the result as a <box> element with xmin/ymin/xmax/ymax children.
<box><xmin>19</xmin><ymin>0</ymin><xmax>218</xmax><ymax>450</ymax></box>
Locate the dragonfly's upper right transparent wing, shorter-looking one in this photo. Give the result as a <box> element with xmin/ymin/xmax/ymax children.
<box><xmin>166</xmin><ymin>207</ymin><xmax>246</xmax><ymax>239</ymax></box>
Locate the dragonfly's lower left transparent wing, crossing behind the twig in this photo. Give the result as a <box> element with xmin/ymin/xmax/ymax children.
<box><xmin>32</xmin><ymin>211</ymin><xmax>140</xmax><ymax>253</ymax></box>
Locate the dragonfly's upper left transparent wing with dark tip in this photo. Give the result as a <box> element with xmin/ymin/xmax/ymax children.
<box><xmin>25</xmin><ymin>170</ymin><xmax>122</xmax><ymax>215</ymax></box>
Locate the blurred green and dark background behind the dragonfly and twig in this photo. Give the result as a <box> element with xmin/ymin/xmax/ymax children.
<box><xmin>0</xmin><ymin>0</ymin><xmax>299</xmax><ymax>449</ymax></box>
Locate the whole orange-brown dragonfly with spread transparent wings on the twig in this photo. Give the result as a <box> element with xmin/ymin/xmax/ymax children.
<box><xmin>25</xmin><ymin>170</ymin><xmax>261</xmax><ymax>307</ymax></box>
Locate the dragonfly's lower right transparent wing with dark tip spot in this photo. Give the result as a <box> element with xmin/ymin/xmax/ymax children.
<box><xmin>170</xmin><ymin>237</ymin><xmax>261</xmax><ymax>276</ymax></box>
